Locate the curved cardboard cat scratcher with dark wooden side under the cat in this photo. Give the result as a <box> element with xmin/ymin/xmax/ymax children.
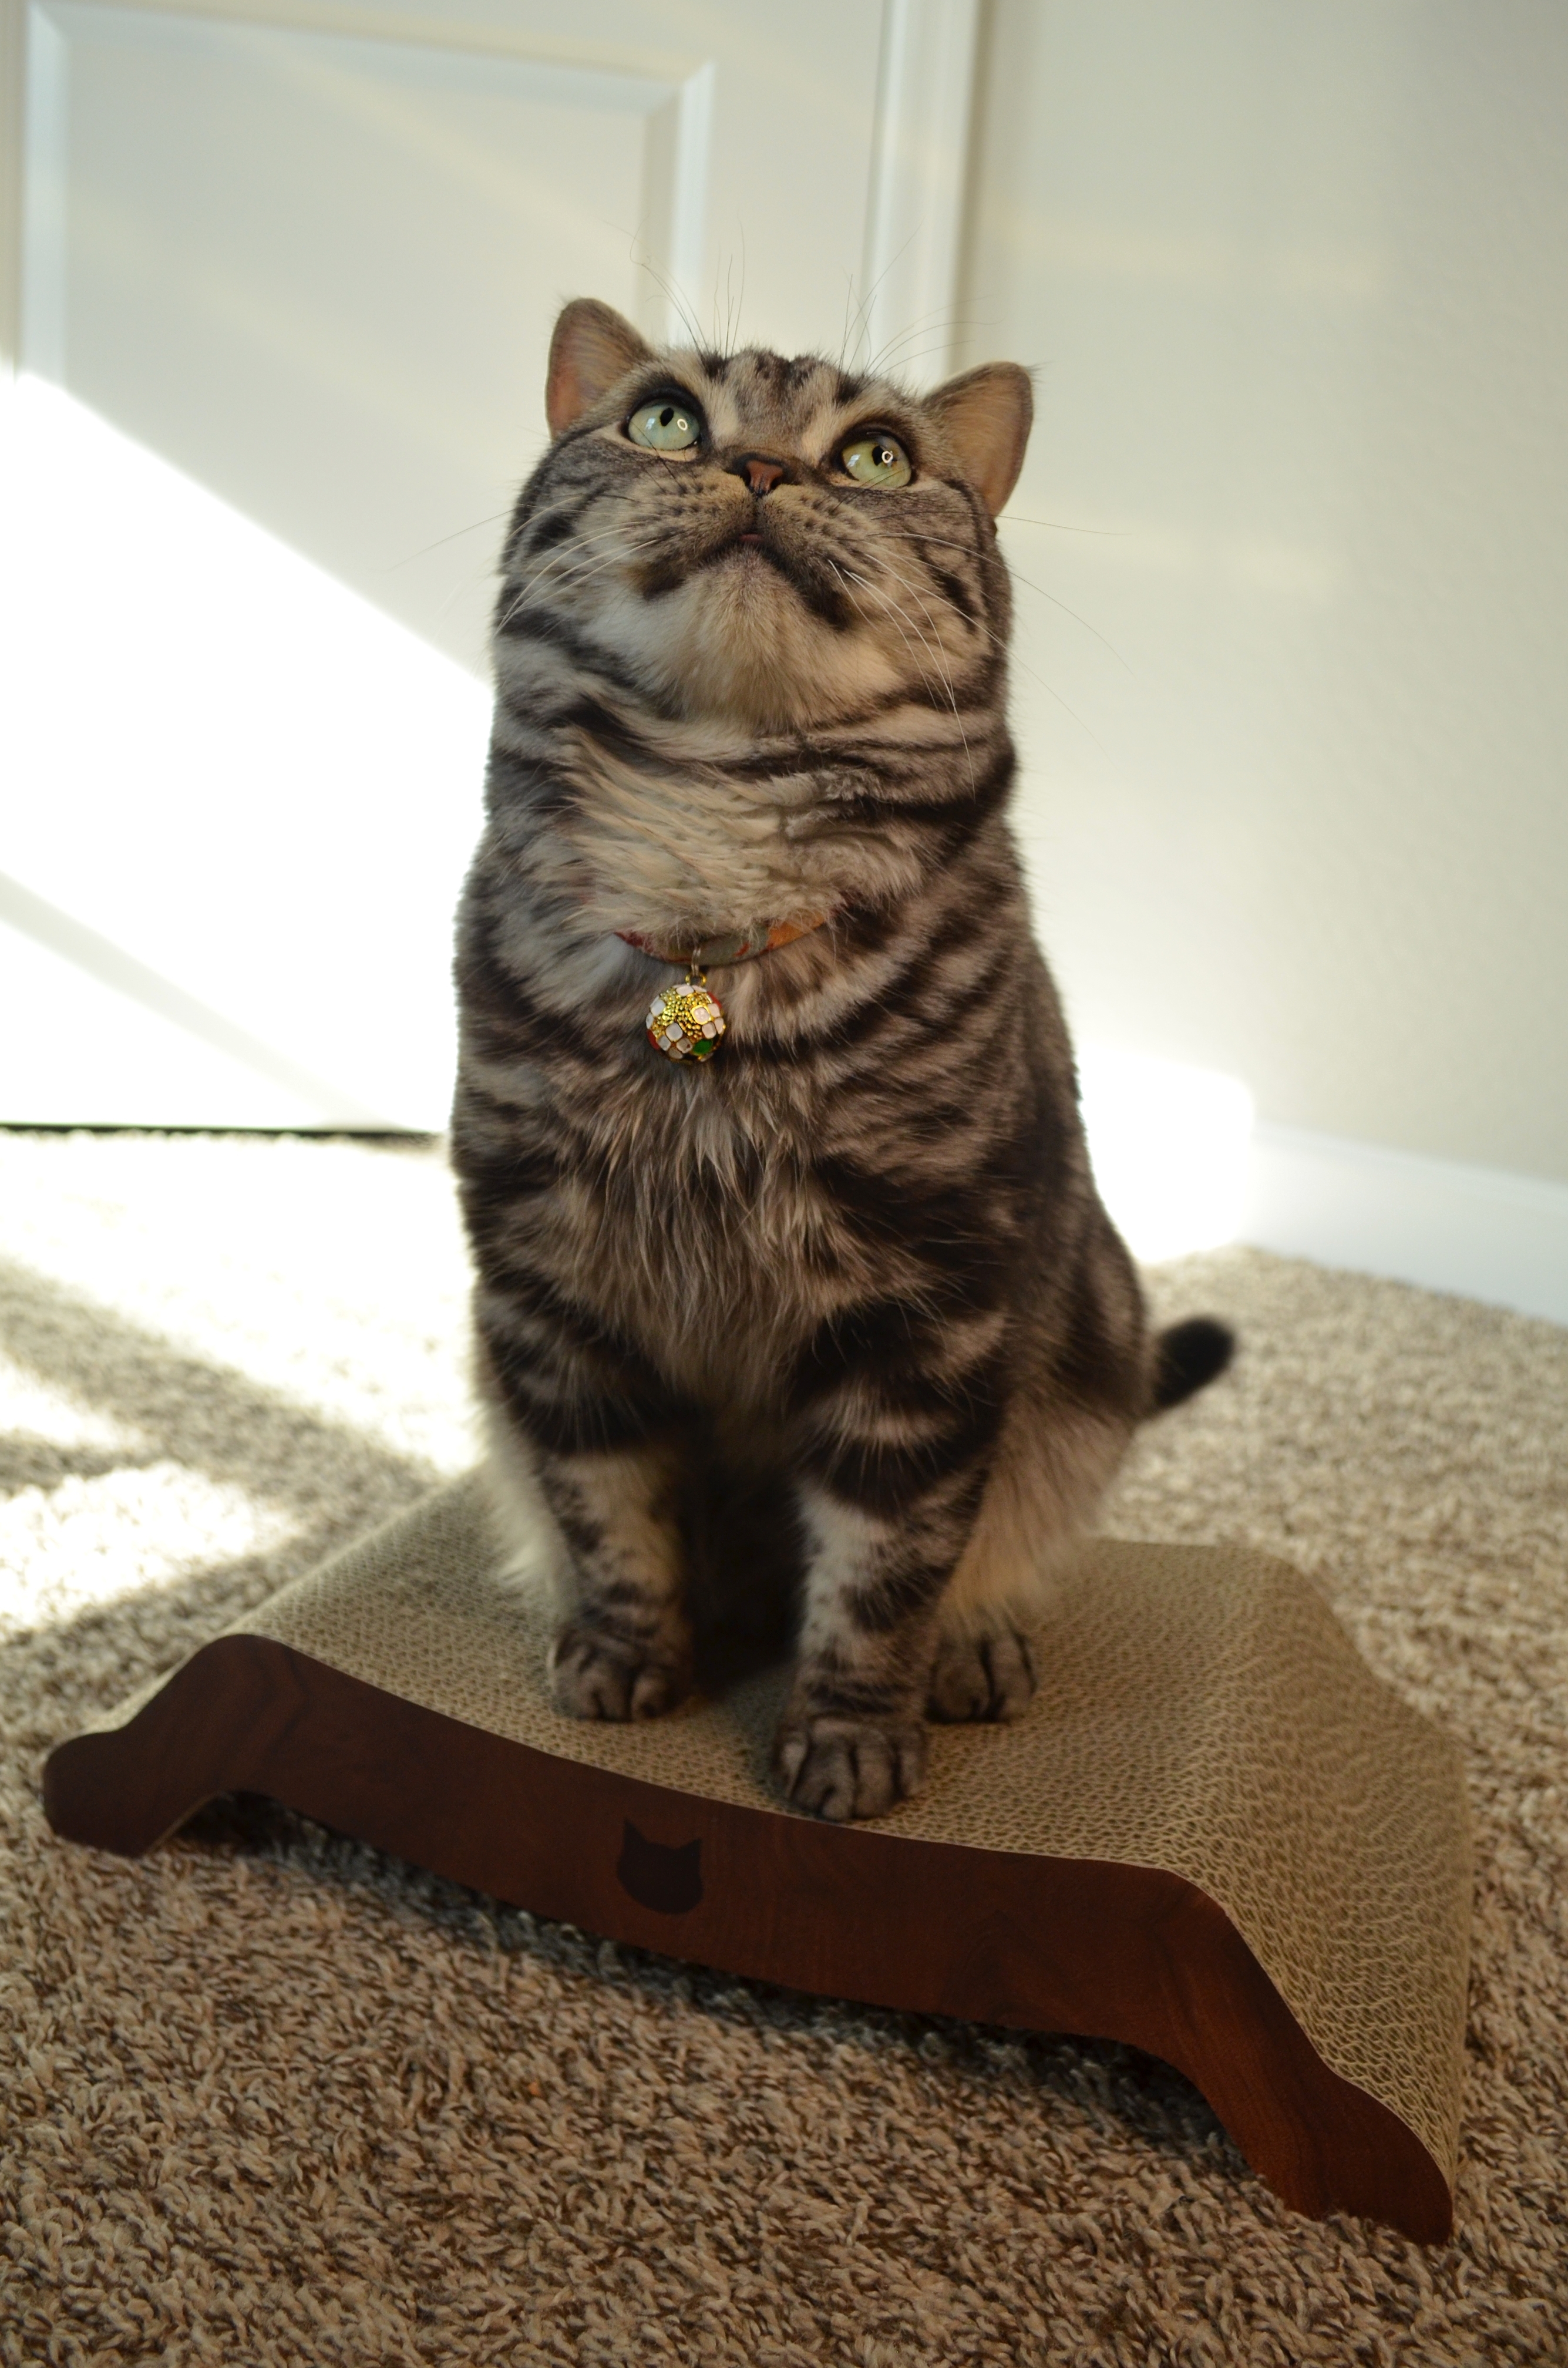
<box><xmin>45</xmin><ymin>1480</ymin><xmax>1471</xmax><ymax>2242</ymax></box>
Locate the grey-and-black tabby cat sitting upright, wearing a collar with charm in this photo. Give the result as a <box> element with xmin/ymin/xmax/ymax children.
<box><xmin>452</xmin><ymin>301</ymin><xmax>1229</xmax><ymax>1819</ymax></box>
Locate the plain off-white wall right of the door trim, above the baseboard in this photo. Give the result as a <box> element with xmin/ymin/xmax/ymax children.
<box><xmin>964</xmin><ymin>0</ymin><xmax>1568</xmax><ymax>1222</ymax></box>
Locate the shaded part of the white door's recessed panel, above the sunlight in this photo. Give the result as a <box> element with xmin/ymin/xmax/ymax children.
<box><xmin>23</xmin><ymin>0</ymin><xmax>705</xmax><ymax>668</ymax></box>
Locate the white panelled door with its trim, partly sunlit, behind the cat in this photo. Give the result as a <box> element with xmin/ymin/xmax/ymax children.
<box><xmin>0</xmin><ymin>0</ymin><xmax>976</xmax><ymax>1127</ymax></box>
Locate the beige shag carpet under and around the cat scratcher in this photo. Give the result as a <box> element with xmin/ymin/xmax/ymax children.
<box><xmin>0</xmin><ymin>1134</ymin><xmax>1568</xmax><ymax>2368</ymax></box>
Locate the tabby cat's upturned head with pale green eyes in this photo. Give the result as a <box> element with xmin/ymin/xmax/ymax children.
<box><xmin>497</xmin><ymin>301</ymin><xmax>1032</xmax><ymax>732</ymax></box>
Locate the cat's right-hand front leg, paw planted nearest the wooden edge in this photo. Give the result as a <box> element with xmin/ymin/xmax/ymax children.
<box><xmin>775</xmin><ymin>1471</ymin><xmax>983</xmax><ymax>1821</ymax></box>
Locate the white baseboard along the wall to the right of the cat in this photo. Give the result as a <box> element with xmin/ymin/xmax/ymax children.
<box><xmin>1236</xmin><ymin>1125</ymin><xmax>1568</xmax><ymax>1324</ymax></box>
